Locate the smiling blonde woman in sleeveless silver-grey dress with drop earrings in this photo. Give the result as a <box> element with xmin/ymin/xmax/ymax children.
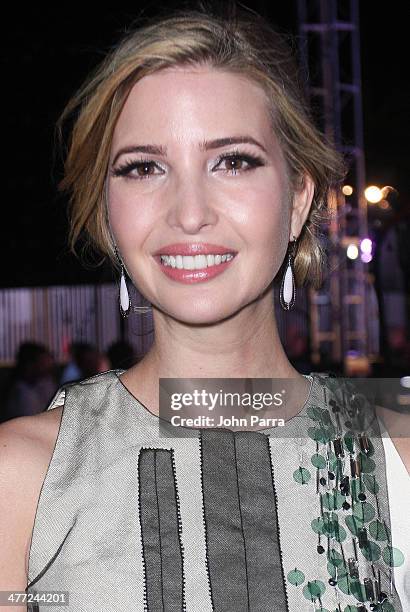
<box><xmin>1</xmin><ymin>4</ymin><xmax>404</xmax><ymax>612</ymax></box>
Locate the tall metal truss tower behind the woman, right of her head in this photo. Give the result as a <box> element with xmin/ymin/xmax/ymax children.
<box><xmin>298</xmin><ymin>0</ymin><xmax>371</xmax><ymax>372</ymax></box>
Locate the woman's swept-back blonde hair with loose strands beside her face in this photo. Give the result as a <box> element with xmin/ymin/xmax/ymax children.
<box><xmin>56</xmin><ymin>2</ymin><xmax>346</xmax><ymax>287</ymax></box>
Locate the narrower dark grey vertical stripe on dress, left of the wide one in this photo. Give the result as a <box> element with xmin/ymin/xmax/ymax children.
<box><xmin>138</xmin><ymin>449</ymin><xmax>184</xmax><ymax>612</ymax></box>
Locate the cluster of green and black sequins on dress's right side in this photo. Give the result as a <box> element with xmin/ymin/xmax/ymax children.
<box><xmin>304</xmin><ymin>378</ymin><xmax>404</xmax><ymax>612</ymax></box>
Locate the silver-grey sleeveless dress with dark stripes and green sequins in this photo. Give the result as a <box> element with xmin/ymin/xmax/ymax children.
<box><xmin>26</xmin><ymin>370</ymin><xmax>410</xmax><ymax>612</ymax></box>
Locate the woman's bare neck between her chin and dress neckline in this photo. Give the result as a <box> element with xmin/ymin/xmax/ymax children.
<box><xmin>121</xmin><ymin>292</ymin><xmax>309</xmax><ymax>420</ymax></box>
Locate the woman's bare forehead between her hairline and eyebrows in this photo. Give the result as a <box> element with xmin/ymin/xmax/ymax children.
<box><xmin>114</xmin><ymin>66</ymin><xmax>273</xmax><ymax>144</ymax></box>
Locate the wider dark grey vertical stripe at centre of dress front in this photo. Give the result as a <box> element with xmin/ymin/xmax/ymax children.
<box><xmin>201</xmin><ymin>429</ymin><xmax>287</xmax><ymax>612</ymax></box>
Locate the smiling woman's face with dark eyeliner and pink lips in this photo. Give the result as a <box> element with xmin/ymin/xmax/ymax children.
<box><xmin>107</xmin><ymin>67</ymin><xmax>313</xmax><ymax>323</ymax></box>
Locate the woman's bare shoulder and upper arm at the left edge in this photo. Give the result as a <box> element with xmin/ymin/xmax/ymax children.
<box><xmin>0</xmin><ymin>406</ymin><xmax>63</xmax><ymax>590</ymax></box>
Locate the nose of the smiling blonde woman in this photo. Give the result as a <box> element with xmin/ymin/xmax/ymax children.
<box><xmin>167</xmin><ymin>174</ymin><xmax>218</xmax><ymax>234</ymax></box>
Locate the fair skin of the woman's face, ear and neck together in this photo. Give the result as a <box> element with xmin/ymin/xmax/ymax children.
<box><xmin>107</xmin><ymin>67</ymin><xmax>314</xmax><ymax>418</ymax></box>
